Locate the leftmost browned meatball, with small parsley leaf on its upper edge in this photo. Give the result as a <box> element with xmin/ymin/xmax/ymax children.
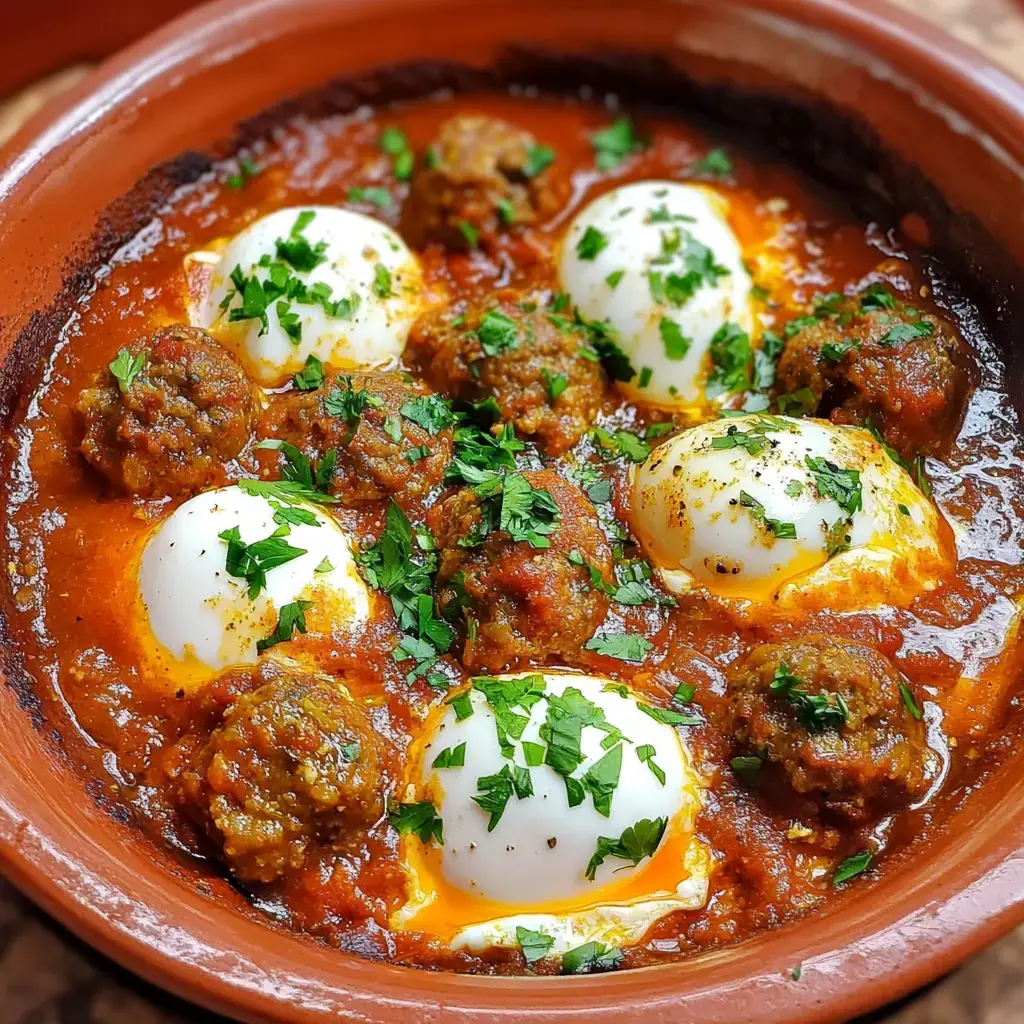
<box><xmin>77</xmin><ymin>324</ymin><xmax>257</xmax><ymax>498</ymax></box>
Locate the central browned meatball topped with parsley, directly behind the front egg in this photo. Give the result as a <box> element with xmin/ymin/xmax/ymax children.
<box><xmin>429</xmin><ymin>470</ymin><xmax>611</xmax><ymax>672</ymax></box>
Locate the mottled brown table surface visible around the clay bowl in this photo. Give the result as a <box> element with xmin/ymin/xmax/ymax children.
<box><xmin>0</xmin><ymin>0</ymin><xmax>1024</xmax><ymax>1024</ymax></box>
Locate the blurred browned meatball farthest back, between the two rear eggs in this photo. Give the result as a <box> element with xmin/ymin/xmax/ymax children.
<box><xmin>401</xmin><ymin>115</ymin><xmax>560</xmax><ymax>250</ymax></box>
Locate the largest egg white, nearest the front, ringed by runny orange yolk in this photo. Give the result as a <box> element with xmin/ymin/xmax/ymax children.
<box><xmin>392</xmin><ymin>671</ymin><xmax>711</xmax><ymax>955</ymax></box>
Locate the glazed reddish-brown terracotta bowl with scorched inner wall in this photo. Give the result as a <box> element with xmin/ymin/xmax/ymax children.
<box><xmin>0</xmin><ymin>0</ymin><xmax>1024</xmax><ymax>1024</ymax></box>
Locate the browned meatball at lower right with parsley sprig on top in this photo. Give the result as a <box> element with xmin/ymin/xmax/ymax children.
<box><xmin>725</xmin><ymin>636</ymin><xmax>934</xmax><ymax>820</ymax></box>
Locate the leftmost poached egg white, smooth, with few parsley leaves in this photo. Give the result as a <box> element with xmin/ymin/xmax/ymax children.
<box><xmin>137</xmin><ymin>486</ymin><xmax>370</xmax><ymax>681</ymax></box>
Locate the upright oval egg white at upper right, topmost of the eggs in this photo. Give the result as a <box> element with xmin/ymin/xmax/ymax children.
<box><xmin>559</xmin><ymin>181</ymin><xmax>755</xmax><ymax>410</ymax></box>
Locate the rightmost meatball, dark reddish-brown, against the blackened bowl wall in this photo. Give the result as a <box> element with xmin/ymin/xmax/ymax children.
<box><xmin>777</xmin><ymin>291</ymin><xmax>968</xmax><ymax>459</ymax></box>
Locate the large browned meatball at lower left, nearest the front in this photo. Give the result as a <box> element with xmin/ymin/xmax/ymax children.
<box><xmin>177</xmin><ymin>669</ymin><xmax>384</xmax><ymax>883</ymax></box>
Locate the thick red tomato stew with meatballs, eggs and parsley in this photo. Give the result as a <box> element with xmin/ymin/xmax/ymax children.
<box><xmin>2</xmin><ymin>91</ymin><xmax>1024</xmax><ymax>974</ymax></box>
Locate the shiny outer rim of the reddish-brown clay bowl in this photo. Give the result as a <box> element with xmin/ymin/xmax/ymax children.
<box><xmin>0</xmin><ymin>0</ymin><xmax>1024</xmax><ymax>1024</ymax></box>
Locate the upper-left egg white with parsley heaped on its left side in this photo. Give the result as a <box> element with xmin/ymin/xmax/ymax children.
<box><xmin>185</xmin><ymin>206</ymin><xmax>424</xmax><ymax>387</ymax></box>
